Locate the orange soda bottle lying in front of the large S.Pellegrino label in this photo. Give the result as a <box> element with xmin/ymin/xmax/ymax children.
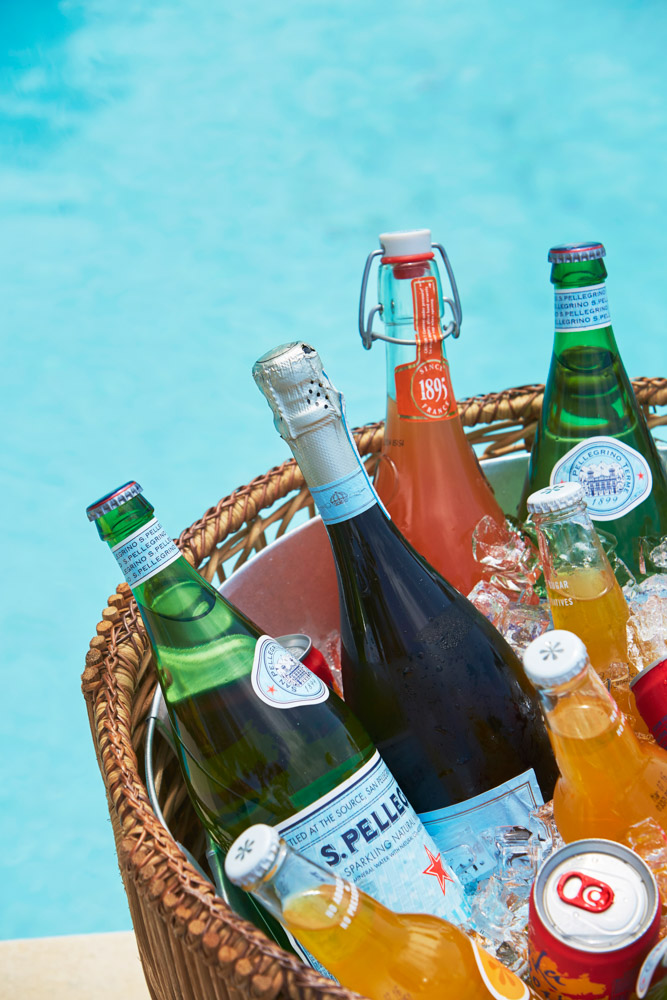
<box><xmin>225</xmin><ymin>824</ymin><xmax>536</xmax><ymax>1000</ymax></box>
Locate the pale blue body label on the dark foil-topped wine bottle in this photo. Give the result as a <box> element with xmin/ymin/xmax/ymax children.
<box><xmin>419</xmin><ymin>767</ymin><xmax>544</xmax><ymax>891</ymax></box>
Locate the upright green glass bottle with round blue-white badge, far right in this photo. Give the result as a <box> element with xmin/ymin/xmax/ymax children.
<box><xmin>518</xmin><ymin>243</ymin><xmax>667</xmax><ymax>573</ymax></box>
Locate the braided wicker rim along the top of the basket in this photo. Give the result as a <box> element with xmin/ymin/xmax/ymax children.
<box><xmin>82</xmin><ymin>378</ymin><xmax>667</xmax><ymax>1000</ymax></box>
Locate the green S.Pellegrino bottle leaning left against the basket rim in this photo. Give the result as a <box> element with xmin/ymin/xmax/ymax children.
<box><xmin>87</xmin><ymin>482</ymin><xmax>469</xmax><ymax>923</ymax></box>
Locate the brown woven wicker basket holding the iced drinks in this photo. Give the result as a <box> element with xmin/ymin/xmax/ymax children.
<box><xmin>83</xmin><ymin>378</ymin><xmax>667</xmax><ymax>1000</ymax></box>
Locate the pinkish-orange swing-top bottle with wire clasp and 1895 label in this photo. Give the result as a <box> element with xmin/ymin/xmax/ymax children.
<box><xmin>359</xmin><ymin>229</ymin><xmax>505</xmax><ymax>594</ymax></box>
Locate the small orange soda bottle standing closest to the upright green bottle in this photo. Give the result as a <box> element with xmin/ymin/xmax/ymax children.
<box><xmin>527</xmin><ymin>482</ymin><xmax>648</xmax><ymax>735</ymax></box>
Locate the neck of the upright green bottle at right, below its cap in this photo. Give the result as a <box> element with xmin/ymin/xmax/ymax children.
<box><xmin>551</xmin><ymin>260</ymin><xmax>618</xmax><ymax>354</ymax></box>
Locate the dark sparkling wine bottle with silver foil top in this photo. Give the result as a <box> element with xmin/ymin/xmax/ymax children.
<box><xmin>253</xmin><ymin>343</ymin><xmax>556</xmax><ymax>884</ymax></box>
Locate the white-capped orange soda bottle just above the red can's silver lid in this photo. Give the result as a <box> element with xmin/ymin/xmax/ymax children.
<box><xmin>523</xmin><ymin>629</ymin><xmax>667</xmax><ymax>846</ymax></box>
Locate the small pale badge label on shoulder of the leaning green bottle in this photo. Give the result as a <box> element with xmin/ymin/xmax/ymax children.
<box><xmin>250</xmin><ymin>635</ymin><xmax>329</xmax><ymax>708</ymax></box>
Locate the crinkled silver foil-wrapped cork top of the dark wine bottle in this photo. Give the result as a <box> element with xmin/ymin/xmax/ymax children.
<box><xmin>252</xmin><ymin>341</ymin><xmax>343</xmax><ymax>444</ymax></box>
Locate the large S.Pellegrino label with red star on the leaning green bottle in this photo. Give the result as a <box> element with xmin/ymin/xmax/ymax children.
<box><xmin>276</xmin><ymin>751</ymin><xmax>470</xmax><ymax>924</ymax></box>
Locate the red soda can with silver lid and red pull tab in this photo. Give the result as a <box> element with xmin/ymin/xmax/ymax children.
<box><xmin>528</xmin><ymin>839</ymin><xmax>660</xmax><ymax>1000</ymax></box>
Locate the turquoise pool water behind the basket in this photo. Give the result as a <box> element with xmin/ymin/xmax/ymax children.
<box><xmin>0</xmin><ymin>0</ymin><xmax>667</xmax><ymax>938</ymax></box>
